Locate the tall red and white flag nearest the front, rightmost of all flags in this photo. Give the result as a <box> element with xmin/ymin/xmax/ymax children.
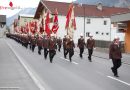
<box><xmin>65</xmin><ymin>4</ymin><xmax>76</xmax><ymax>38</ymax></box>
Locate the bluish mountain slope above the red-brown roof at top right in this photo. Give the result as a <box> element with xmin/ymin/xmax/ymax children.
<box><xmin>75</xmin><ymin>0</ymin><xmax>130</xmax><ymax>7</ymax></box>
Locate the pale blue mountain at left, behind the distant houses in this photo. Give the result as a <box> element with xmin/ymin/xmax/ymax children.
<box><xmin>6</xmin><ymin>8</ymin><xmax>36</xmax><ymax>26</ymax></box>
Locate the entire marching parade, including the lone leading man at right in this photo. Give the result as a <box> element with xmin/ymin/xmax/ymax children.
<box><xmin>6</xmin><ymin>33</ymin><xmax>122</xmax><ymax>77</ymax></box>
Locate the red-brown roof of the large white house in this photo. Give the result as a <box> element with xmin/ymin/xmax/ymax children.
<box><xmin>34</xmin><ymin>0</ymin><xmax>130</xmax><ymax>19</ymax></box>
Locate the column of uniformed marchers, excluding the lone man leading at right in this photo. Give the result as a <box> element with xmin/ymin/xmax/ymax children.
<box><xmin>6</xmin><ymin>33</ymin><xmax>95</xmax><ymax>63</ymax></box>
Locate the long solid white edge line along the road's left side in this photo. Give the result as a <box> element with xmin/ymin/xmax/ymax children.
<box><xmin>6</xmin><ymin>41</ymin><xmax>45</xmax><ymax>90</ymax></box>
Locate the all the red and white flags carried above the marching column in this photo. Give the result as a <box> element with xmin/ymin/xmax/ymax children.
<box><xmin>14</xmin><ymin>4</ymin><xmax>76</xmax><ymax>38</ymax></box>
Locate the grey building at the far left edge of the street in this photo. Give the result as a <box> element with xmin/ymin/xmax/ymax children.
<box><xmin>0</xmin><ymin>15</ymin><xmax>6</xmax><ymax>37</ymax></box>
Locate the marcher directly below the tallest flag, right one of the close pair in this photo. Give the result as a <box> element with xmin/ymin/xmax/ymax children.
<box><xmin>65</xmin><ymin>36</ymin><xmax>75</xmax><ymax>62</ymax></box>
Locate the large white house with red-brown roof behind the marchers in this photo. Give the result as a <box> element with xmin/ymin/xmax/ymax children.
<box><xmin>34</xmin><ymin>0</ymin><xmax>130</xmax><ymax>47</ymax></box>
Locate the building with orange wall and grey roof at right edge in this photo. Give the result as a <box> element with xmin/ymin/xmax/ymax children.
<box><xmin>111</xmin><ymin>12</ymin><xmax>130</xmax><ymax>53</ymax></box>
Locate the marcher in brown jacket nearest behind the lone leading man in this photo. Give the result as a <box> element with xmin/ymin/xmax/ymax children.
<box><xmin>86</xmin><ymin>34</ymin><xmax>95</xmax><ymax>62</ymax></box>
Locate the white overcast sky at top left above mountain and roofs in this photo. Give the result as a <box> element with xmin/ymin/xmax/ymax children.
<box><xmin>0</xmin><ymin>0</ymin><xmax>75</xmax><ymax>17</ymax></box>
